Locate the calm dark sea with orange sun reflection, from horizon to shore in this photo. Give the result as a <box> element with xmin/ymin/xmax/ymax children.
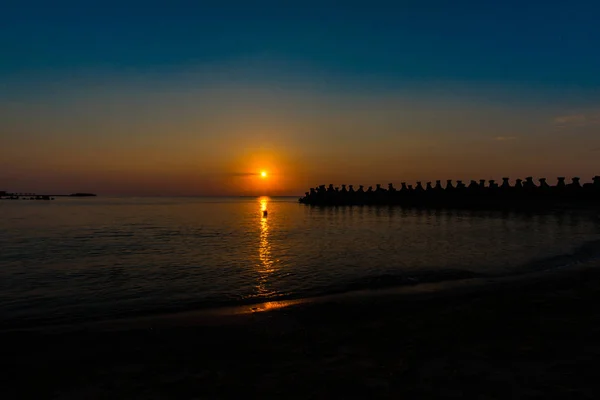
<box><xmin>0</xmin><ymin>198</ymin><xmax>600</xmax><ymax>326</ymax></box>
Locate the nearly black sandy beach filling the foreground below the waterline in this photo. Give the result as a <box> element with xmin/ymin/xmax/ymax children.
<box><xmin>0</xmin><ymin>268</ymin><xmax>600</xmax><ymax>399</ymax></box>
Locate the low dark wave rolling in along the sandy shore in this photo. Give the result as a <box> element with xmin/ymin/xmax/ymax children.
<box><xmin>3</xmin><ymin>240</ymin><xmax>600</xmax><ymax>329</ymax></box>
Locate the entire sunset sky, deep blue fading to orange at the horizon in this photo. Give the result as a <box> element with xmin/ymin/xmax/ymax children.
<box><xmin>0</xmin><ymin>0</ymin><xmax>600</xmax><ymax>196</ymax></box>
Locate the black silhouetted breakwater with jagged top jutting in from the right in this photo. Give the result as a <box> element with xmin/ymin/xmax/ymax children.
<box><xmin>299</xmin><ymin>176</ymin><xmax>600</xmax><ymax>208</ymax></box>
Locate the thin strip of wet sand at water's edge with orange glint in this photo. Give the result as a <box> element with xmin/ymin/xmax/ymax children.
<box><xmin>0</xmin><ymin>255</ymin><xmax>600</xmax><ymax>335</ymax></box>
